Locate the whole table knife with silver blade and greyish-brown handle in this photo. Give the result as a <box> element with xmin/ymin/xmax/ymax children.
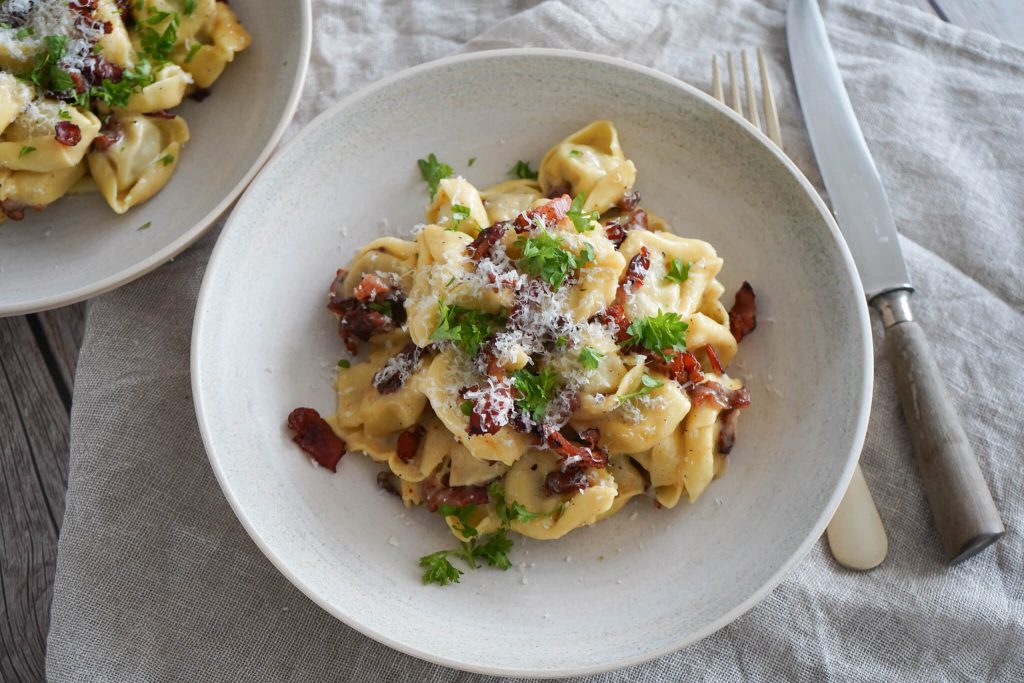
<box><xmin>786</xmin><ymin>0</ymin><xmax>1006</xmax><ymax>564</ymax></box>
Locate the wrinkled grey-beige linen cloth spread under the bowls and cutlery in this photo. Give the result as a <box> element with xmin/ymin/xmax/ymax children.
<box><xmin>47</xmin><ymin>0</ymin><xmax>1024</xmax><ymax>683</ymax></box>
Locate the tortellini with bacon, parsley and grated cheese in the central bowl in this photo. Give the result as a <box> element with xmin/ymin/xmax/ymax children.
<box><xmin>288</xmin><ymin>121</ymin><xmax>756</xmax><ymax>585</ymax></box>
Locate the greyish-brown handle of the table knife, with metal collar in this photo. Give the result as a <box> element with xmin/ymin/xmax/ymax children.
<box><xmin>870</xmin><ymin>290</ymin><xmax>1006</xmax><ymax>564</ymax></box>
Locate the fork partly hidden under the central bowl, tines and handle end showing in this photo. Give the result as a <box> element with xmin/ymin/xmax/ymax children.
<box><xmin>711</xmin><ymin>47</ymin><xmax>889</xmax><ymax>571</ymax></box>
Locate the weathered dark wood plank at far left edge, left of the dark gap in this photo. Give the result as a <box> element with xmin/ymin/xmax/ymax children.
<box><xmin>0</xmin><ymin>317</ymin><xmax>69</xmax><ymax>681</ymax></box>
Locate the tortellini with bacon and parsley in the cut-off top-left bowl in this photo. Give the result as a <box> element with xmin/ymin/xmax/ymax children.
<box><xmin>0</xmin><ymin>0</ymin><xmax>252</xmax><ymax>221</ymax></box>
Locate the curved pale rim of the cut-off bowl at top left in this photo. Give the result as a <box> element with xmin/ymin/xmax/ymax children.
<box><xmin>0</xmin><ymin>0</ymin><xmax>312</xmax><ymax>317</ymax></box>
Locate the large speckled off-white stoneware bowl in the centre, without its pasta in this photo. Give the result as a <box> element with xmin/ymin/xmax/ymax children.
<box><xmin>193</xmin><ymin>49</ymin><xmax>871</xmax><ymax>677</ymax></box>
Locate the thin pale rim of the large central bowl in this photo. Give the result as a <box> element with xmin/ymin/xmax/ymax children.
<box><xmin>190</xmin><ymin>47</ymin><xmax>874</xmax><ymax>679</ymax></box>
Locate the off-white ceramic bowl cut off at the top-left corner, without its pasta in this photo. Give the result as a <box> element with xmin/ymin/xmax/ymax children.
<box><xmin>0</xmin><ymin>0</ymin><xmax>312</xmax><ymax>315</ymax></box>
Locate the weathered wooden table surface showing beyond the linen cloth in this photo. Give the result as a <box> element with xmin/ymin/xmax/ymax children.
<box><xmin>0</xmin><ymin>0</ymin><xmax>1024</xmax><ymax>681</ymax></box>
